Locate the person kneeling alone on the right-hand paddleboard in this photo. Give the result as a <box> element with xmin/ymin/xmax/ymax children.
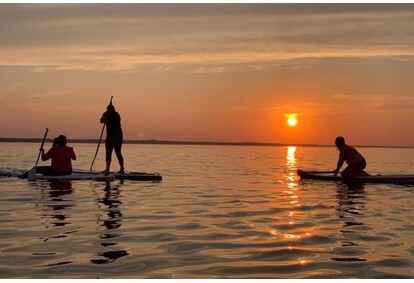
<box><xmin>332</xmin><ymin>137</ymin><xmax>367</xmax><ymax>177</ymax></box>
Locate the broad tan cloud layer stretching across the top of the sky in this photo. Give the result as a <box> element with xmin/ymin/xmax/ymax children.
<box><xmin>0</xmin><ymin>4</ymin><xmax>414</xmax><ymax>73</ymax></box>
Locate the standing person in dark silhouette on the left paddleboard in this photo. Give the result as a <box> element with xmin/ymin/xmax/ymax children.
<box><xmin>100</xmin><ymin>102</ymin><xmax>125</xmax><ymax>174</ymax></box>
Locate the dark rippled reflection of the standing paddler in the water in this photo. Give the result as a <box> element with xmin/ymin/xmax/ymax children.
<box><xmin>91</xmin><ymin>182</ymin><xmax>128</xmax><ymax>264</ymax></box>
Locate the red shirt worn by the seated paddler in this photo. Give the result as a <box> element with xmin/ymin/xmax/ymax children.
<box><xmin>42</xmin><ymin>145</ymin><xmax>76</xmax><ymax>173</ymax></box>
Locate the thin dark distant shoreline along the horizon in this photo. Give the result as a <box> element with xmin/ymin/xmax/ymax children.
<box><xmin>0</xmin><ymin>138</ymin><xmax>414</xmax><ymax>148</ymax></box>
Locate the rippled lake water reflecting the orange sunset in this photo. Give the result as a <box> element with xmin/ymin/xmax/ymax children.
<box><xmin>0</xmin><ymin>143</ymin><xmax>414</xmax><ymax>278</ymax></box>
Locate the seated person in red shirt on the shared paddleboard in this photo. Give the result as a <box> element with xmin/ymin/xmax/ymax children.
<box><xmin>36</xmin><ymin>135</ymin><xmax>76</xmax><ymax>176</ymax></box>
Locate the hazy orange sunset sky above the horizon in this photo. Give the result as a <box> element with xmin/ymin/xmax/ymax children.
<box><xmin>0</xmin><ymin>4</ymin><xmax>414</xmax><ymax>146</ymax></box>
